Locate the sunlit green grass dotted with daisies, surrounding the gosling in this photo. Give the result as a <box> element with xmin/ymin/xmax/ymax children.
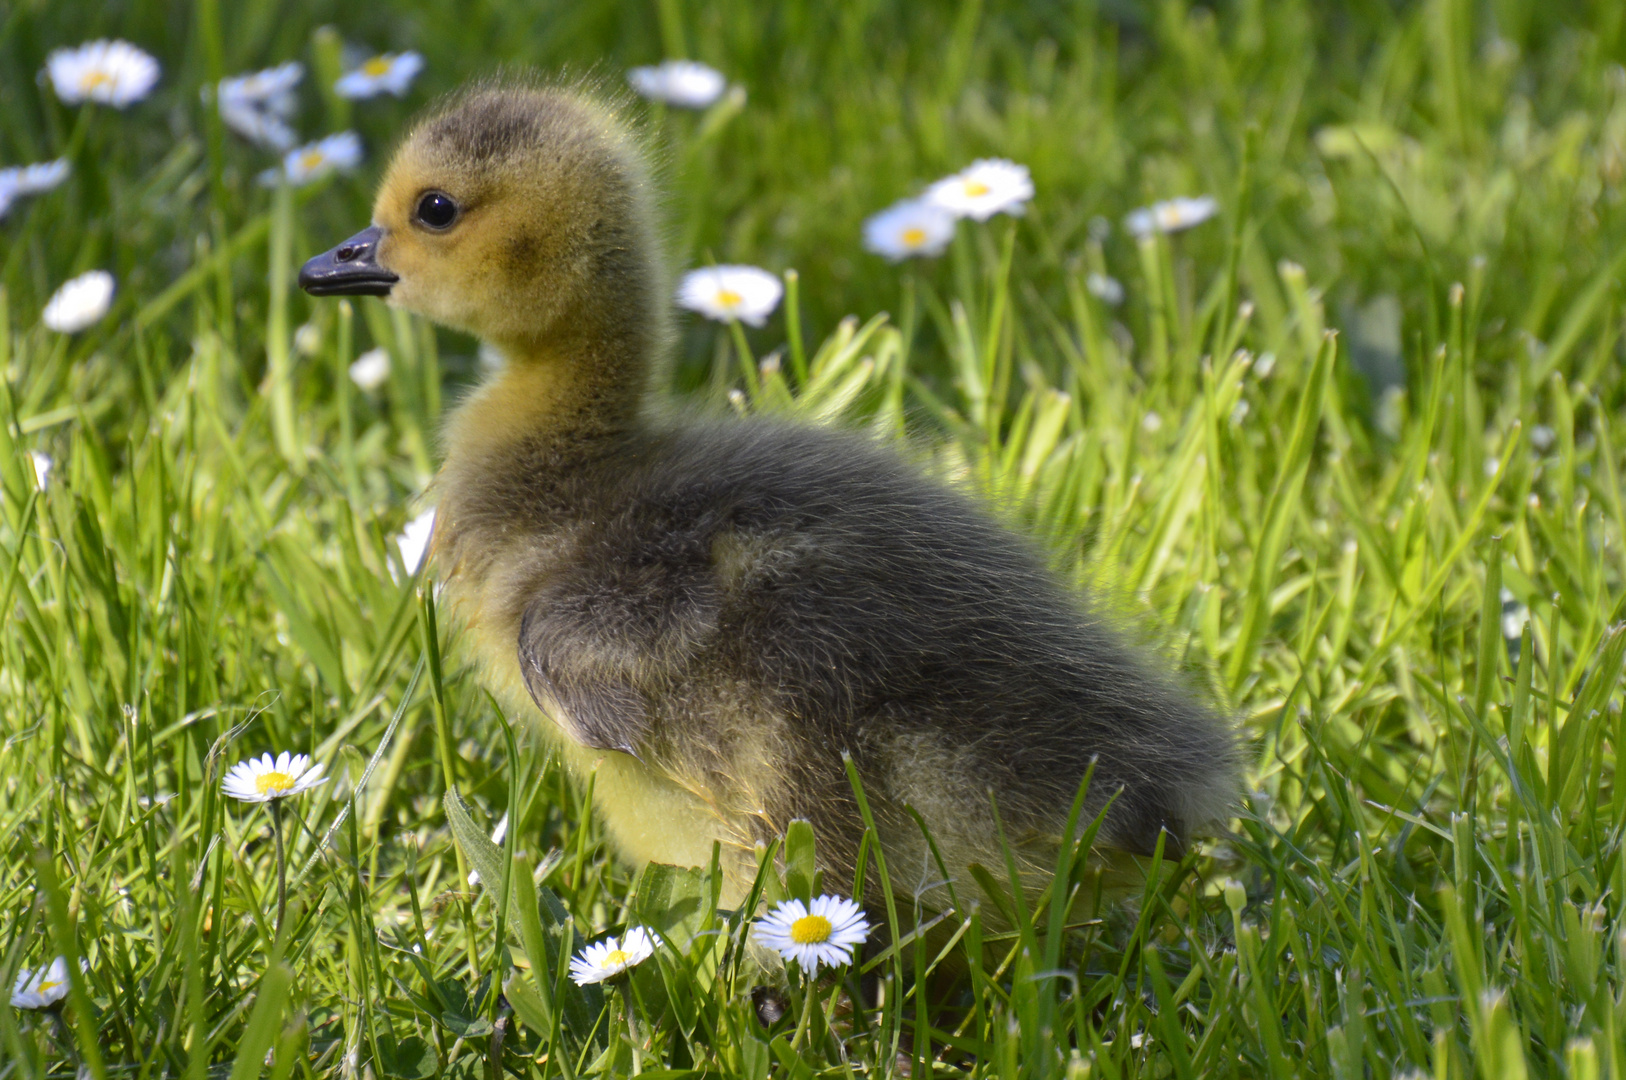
<box><xmin>0</xmin><ymin>0</ymin><xmax>1626</xmax><ymax>1080</ymax></box>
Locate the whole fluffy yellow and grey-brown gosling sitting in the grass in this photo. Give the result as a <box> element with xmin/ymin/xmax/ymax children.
<box><xmin>299</xmin><ymin>85</ymin><xmax>1239</xmax><ymax>903</ymax></box>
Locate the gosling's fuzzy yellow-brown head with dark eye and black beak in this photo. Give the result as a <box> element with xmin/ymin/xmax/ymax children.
<box><xmin>299</xmin><ymin>85</ymin><xmax>665</xmax><ymax>356</ymax></box>
